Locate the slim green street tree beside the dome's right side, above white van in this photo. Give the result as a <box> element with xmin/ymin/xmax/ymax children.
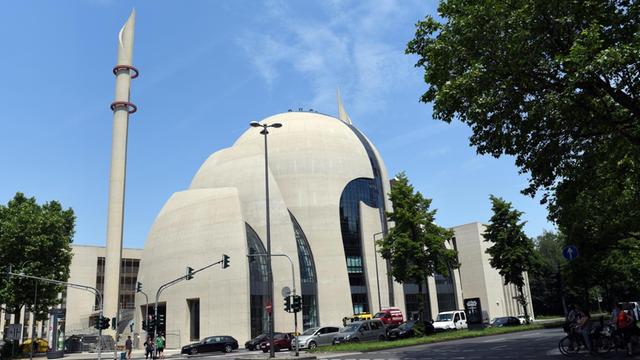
<box><xmin>377</xmin><ymin>173</ymin><xmax>459</xmax><ymax>321</ymax></box>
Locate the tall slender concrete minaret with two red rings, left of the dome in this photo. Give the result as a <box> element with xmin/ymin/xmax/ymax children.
<box><xmin>103</xmin><ymin>9</ymin><xmax>138</xmax><ymax>334</ymax></box>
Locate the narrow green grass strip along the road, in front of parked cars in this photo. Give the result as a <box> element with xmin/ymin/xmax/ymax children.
<box><xmin>309</xmin><ymin>321</ymin><xmax>563</xmax><ymax>352</ymax></box>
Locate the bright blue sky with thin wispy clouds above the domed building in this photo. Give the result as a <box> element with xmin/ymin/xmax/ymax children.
<box><xmin>0</xmin><ymin>0</ymin><xmax>553</xmax><ymax>248</ymax></box>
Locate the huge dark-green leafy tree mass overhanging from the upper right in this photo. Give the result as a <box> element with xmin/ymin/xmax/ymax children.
<box><xmin>406</xmin><ymin>0</ymin><xmax>640</xmax><ymax>310</ymax></box>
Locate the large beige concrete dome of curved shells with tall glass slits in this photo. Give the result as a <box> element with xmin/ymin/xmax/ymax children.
<box><xmin>137</xmin><ymin>112</ymin><xmax>404</xmax><ymax>341</ymax></box>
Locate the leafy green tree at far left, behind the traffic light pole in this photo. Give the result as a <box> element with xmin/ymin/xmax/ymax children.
<box><xmin>0</xmin><ymin>193</ymin><xmax>75</xmax><ymax>323</ymax></box>
